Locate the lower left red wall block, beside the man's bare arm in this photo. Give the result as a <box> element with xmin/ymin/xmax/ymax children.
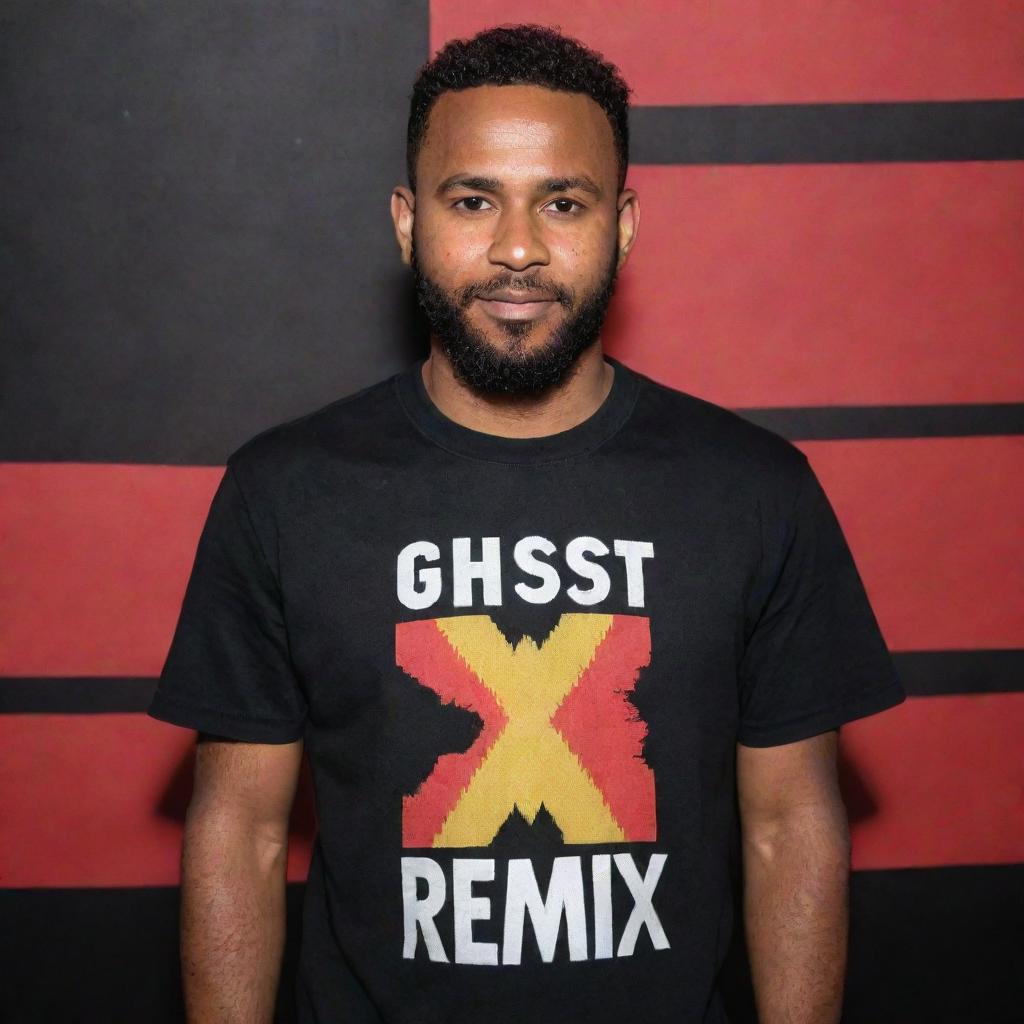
<box><xmin>0</xmin><ymin>715</ymin><xmax>312</xmax><ymax>889</ymax></box>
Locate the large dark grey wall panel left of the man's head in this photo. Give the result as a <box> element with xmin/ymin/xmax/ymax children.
<box><xmin>0</xmin><ymin>0</ymin><xmax>427</xmax><ymax>464</ymax></box>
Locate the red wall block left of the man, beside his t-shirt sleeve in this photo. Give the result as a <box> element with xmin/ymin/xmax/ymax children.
<box><xmin>0</xmin><ymin>463</ymin><xmax>223</xmax><ymax>676</ymax></box>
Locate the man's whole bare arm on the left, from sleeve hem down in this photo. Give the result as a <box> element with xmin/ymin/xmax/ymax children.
<box><xmin>181</xmin><ymin>734</ymin><xmax>302</xmax><ymax>1024</ymax></box>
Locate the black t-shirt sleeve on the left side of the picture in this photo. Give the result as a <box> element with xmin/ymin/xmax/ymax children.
<box><xmin>147</xmin><ymin>460</ymin><xmax>306</xmax><ymax>743</ymax></box>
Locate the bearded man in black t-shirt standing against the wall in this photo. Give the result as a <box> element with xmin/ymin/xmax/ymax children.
<box><xmin>151</xmin><ymin>27</ymin><xmax>904</xmax><ymax>1024</ymax></box>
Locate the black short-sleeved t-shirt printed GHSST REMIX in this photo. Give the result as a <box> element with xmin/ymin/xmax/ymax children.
<box><xmin>150</xmin><ymin>358</ymin><xmax>905</xmax><ymax>1024</ymax></box>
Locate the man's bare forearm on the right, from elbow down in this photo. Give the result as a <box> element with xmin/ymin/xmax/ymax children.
<box><xmin>743</xmin><ymin>809</ymin><xmax>850</xmax><ymax>1024</ymax></box>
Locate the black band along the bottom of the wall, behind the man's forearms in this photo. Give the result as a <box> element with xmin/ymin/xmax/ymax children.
<box><xmin>0</xmin><ymin>864</ymin><xmax>1024</xmax><ymax>1024</ymax></box>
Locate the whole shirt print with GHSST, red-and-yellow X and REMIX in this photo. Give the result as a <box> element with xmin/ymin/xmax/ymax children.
<box><xmin>394</xmin><ymin>535</ymin><xmax>670</xmax><ymax>967</ymax></box>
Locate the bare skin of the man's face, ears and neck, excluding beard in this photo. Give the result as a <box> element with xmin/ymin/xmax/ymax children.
<box><xmin>391</xmin><ymin>85</ymin><xmax>640</xmax><ymax>437</ymax></box>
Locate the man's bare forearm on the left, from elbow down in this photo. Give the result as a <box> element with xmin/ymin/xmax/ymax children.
<box><xmin>181</xmin><ymin>814</ymin><xmax>287</xmax><ymax>1024</ymax></box>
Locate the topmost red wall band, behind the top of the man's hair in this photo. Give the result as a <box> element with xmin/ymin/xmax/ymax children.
<box><xmin>430</xmin><ymin>0</ymin><xmax>1024</xmax><ymax>104</ymax></box>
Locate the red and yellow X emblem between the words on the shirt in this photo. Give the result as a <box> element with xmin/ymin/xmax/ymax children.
<box><xmin>395</xmin><ymin>612</ymin><xmax>656</xmax><ymax>847</ymax></box>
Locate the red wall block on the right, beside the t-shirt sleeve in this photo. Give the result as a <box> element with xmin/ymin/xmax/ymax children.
<box><xmin>800</xmin><ymin>437</ymin><xmax>1024</xmax><ymax>650</ymax></box>
